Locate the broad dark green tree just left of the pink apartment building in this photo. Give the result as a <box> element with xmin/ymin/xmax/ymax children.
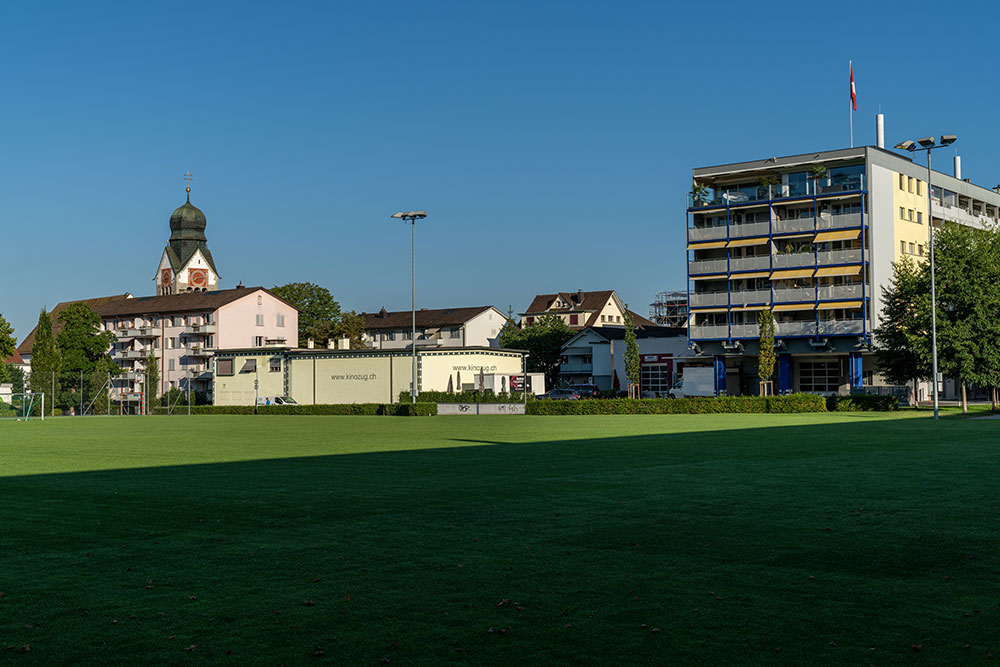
<box><xmin>56</xmin><ymin>302</ymin><xmax>117</xmax><ymax>411</ymax></box>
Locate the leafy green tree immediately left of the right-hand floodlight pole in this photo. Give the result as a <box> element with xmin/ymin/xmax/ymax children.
<box><xmin>874</xmin><ymin>257</ymin><xmax>932</xmax><ymax>400</ymax></box>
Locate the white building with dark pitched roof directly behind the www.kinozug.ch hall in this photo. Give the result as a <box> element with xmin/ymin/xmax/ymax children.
<box><xmin>361</xmin><ymin>306</ymin><xmax>507</xmax><ymax>350</ymax></box>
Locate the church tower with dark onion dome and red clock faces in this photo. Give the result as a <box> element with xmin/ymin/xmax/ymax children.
<box><xmin>153</xmin><ymin>173</ymin><xmax>219</xmax><ymax>295</ymax></box>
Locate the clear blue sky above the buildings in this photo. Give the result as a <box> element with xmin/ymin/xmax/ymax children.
<box><xmin>0</xmin><ymin>1</ymin><xmax>1000</xmax><ymax>339</ymax></box>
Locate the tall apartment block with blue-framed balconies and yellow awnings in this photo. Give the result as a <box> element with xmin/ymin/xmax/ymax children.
<box><xmin>687</xmin><ymin>146</ymin><xmax>1000</xmax><ymax>398</ymax></box>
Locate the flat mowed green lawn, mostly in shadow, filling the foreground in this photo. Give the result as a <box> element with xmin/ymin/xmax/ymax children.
<box><xmin>0</xmin><ymin>413</ymin><xmax>1000</xmax><ymax>665</ymax></box>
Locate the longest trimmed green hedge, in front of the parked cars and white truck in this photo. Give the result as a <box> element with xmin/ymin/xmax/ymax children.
<box><xmin>528</xmin><ymin>394</ymin><xmax>826</xmax><ymax>415</ymax></box>
